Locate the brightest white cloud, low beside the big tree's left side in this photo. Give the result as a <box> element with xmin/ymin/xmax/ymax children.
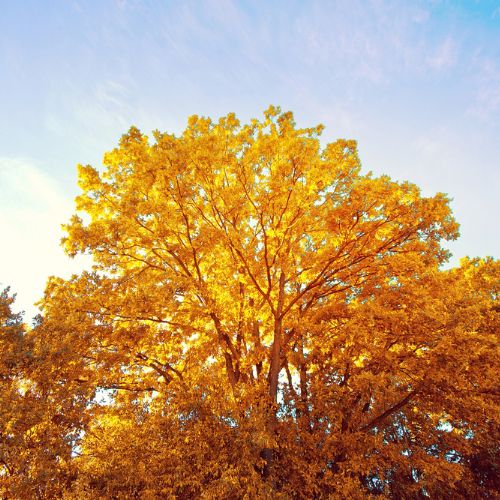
<box><xmin>0</xmin><ymin>158</ymin><xmax>89</xmax><ymax>321</ymax></box>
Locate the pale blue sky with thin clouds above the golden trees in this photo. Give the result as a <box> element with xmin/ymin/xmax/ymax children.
<box><xmin>0</xmin><ymin>0</ymin><xmax>500</xmax><ymax>316</ymax></box>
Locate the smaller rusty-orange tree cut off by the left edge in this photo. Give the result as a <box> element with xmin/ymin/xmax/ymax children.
<box><xmin>0</xmin><ymin>288</ymin><xmax>87</xmax><ymax>499</ymax></box>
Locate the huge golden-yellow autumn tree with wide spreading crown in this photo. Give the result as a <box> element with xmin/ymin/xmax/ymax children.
<box><xmin>14</xmin><ymin>107</ymin><xmax>498</xmax><ymax>498</ymax></box>
